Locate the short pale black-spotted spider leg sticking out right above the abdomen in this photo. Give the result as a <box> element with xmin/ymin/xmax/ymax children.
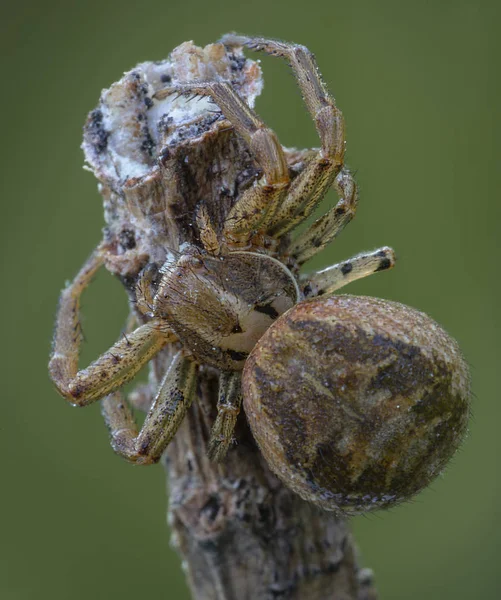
<box><xmin>303</xmin><ymin>246</ymin><xmax>395</xmax><ymax>299</ymax></box>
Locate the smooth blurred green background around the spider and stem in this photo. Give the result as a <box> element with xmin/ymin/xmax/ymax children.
<box><xmin>0</xmin><ymin>0</ymin><xmax>501</xmax><ymax>600</ymax></box>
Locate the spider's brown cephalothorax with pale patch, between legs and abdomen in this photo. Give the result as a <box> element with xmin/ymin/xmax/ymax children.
<box><xmin>146</xmin><ymin>247</ymin><xmax>300</xmax><ymax>371</ymax></box>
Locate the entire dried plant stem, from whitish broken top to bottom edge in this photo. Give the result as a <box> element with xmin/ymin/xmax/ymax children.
<box><xmin>83</xmin><ymin>42</ymin><xmax>376</xmax><ymax>600</ymax></box>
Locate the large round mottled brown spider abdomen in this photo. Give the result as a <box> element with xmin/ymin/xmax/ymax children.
<box><xmin>243</xmin><ymin>296</ymin><xmax>470</xmax><ymax>513</ymax></box>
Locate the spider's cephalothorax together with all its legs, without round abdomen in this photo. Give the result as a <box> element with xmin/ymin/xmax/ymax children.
<box><xmin>50</xmin><ymin>35</ymin><xmax>394</xmax><ymax>464</ymax></box>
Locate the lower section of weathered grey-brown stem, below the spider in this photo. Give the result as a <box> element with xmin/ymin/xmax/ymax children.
<box><xmin>157</xmin><ymin>357</ymin><xmax>376</xmax><ymax>600</ymax></box>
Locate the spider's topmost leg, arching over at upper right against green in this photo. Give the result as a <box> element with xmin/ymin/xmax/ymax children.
<box><xmin>221</xmin><ymin>34</ymin><xmax>356</xmax><ymax>237</ymax></box>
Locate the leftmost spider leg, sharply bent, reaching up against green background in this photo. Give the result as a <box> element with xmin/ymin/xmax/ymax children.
<box><xmin>49</xmin><ymin>248</ymin><xmax>172</xmax><ymax>406</ymax></box>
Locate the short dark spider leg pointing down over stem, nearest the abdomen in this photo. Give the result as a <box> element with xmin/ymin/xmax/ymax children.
<box><xmin>207</xmin><ymin>372</ymin><xmax>242</xmax><ymax>462</ymax></box>
